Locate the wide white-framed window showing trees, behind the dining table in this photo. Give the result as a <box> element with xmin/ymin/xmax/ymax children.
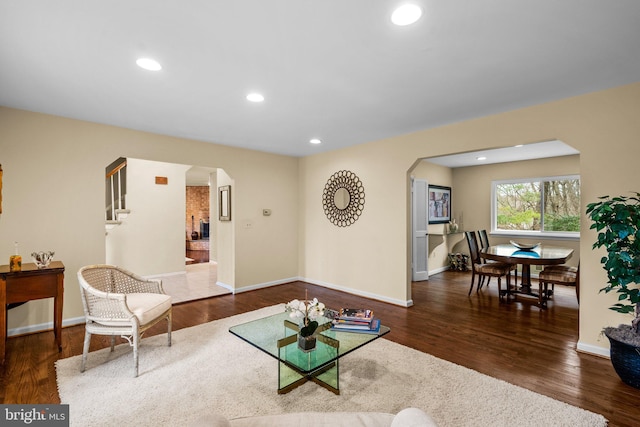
<box><xmin>492</xmin><ymin>175</ymin><xmax>580</xmax><ymax>237</ymax></box>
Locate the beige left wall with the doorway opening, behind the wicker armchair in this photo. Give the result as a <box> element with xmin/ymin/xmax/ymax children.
<box><xmin>0</xmin><ymin>107</ymin><xmax>298</xmax><ymax>332</ymax></box>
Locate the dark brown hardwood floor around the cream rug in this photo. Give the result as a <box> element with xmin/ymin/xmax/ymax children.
<box><xmin>0</xmin><ymin>272</ymin><xmax>640</xmax><ymax>426</ymax></box>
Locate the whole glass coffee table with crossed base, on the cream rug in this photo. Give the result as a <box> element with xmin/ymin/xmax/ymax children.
<box><xmin>229</xmin><ymin>312</ymin><xmax>390</xmax><ymax>394</ymax></box>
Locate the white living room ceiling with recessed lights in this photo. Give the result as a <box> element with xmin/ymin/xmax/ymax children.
<box><xmin>0</xmin><ymin>0</ymin><xmax>640</xmax><ymax>156</ymax></box>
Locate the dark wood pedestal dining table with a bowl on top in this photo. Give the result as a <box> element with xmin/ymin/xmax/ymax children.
<box><xmin>480</xmin><ymin>243</ymin><xmax>573</xmax><ymax>305</ymax></box>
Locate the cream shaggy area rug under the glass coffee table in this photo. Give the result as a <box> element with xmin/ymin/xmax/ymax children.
<box><xmin>56</xmin><ymin>305</ymin><xmax>606</xmax><ymax>427</ymax></box>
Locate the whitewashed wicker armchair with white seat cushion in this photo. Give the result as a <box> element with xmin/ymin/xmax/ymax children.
<box><xmin>78</xmin><ymin>265</ymin><xmax>171</xmax><ymax>377</ymax></box>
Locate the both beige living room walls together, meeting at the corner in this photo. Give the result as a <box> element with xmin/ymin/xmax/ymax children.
<box><xmin>0</xmin><ymin>83</ymin><xmax>640</xmax><ymax>352</ymax></box>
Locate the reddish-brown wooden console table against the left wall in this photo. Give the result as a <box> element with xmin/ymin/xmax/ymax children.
<box><xmin>0</xmin><ymin>261</ymin><xmax>64</xmax><ymax>364</ymax></box>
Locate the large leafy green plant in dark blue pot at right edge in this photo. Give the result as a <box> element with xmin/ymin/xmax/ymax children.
<box><xmin>587</xmin><ymin>193</ymin><xmax>640</xmax><ymax>388</ymax></box>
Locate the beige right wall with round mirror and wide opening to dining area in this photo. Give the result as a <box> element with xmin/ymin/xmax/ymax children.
<box><xmin>300</xmin><ymin>83</ymin><xmax>640</xmax><ymax>352</ymax></box>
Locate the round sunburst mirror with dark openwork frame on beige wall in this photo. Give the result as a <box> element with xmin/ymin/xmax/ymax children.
<box><xmin>322</xmin><ymin>171</ymin><xmax>364</xmax><ymax>227</ymax></box>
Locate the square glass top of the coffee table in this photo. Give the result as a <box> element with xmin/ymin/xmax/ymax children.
<box><xmin>229</xmin><ymin>312</ymin><xmax>390</xmax><ymax>372</ymax></box>
